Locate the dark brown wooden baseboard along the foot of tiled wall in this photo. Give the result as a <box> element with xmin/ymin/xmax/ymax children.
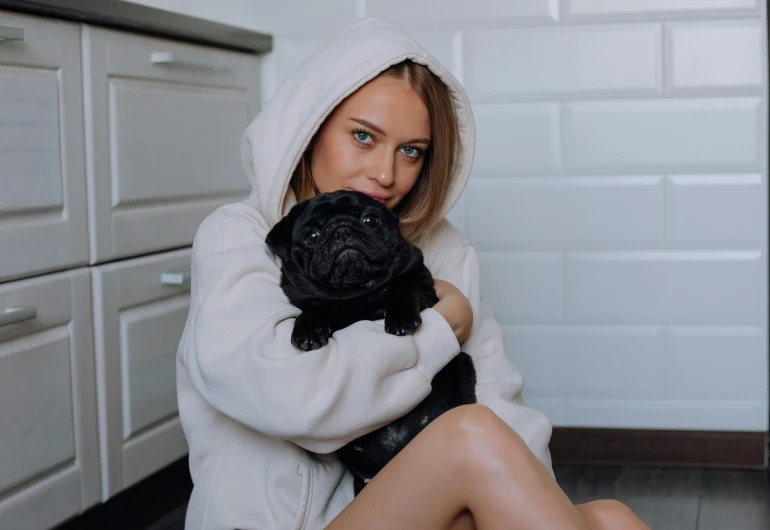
<box><xmin>550</xmin><ymin>427</ymin><xmax>768</xmax><ymax>469</ymax></box>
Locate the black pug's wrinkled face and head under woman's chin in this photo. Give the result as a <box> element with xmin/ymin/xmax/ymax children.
<box><xmin>266</xmin><ymin>191</ymin><xmax>405</xmax><ymax>291</ymax></box>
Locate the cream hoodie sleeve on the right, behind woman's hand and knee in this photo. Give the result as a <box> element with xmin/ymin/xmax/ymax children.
<box><xmin>434</xmin><ymin>235</ymin><xmax>553</xmax><ymax>474</ymax></box>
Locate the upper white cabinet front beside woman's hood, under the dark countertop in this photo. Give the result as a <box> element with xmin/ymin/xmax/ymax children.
<box><xmin>83</xmin><ymin>27</ymin><xmax>259</xmax><ymax>263</ymax></box>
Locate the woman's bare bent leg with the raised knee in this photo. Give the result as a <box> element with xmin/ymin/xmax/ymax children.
<box><xmin>327</xmin><ymin>405</ymin><xmax>592</xmax><ymax>530</ymax></box>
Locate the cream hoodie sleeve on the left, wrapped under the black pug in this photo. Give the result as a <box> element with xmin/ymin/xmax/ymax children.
<box><xmin>181</xmin><ymin>208</ymin><xmax>460</xmax><ymax>453</ymax></box>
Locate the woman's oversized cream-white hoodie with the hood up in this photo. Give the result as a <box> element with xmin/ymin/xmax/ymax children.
<box><xmin>177</xmin><ymin>18</ymin><xmax>551</xmax><ymax>530</ymax></box>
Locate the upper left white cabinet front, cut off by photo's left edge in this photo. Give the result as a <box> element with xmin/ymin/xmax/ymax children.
<box><xmin>0</xmin><ymin>11</ymin><xmax>88</xmax><ymax>281</ymax></box>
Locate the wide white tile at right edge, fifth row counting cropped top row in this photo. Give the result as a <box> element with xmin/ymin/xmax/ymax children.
<box><xmin>565</xmin><ymin>250</ymin><xmax>766</xmax><ymax>325</ymax></box>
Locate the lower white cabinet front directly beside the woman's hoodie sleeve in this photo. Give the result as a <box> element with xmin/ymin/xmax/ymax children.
<box><xmin>92</xmin><ymin>248</ymin><xmax>191</xmax><ymax>500</ymax></box>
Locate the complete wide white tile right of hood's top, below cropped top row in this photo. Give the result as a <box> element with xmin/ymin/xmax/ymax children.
<box><xmin>464</xmin><ymin>24</ymin><xmax>663</xmax><ymax>101</ymax></box>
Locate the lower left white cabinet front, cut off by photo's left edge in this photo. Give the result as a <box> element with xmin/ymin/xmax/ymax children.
<box><xmin>0</xmin><ymin>268</ymin><xmax>100</xmax><ymax>530</ymax></box>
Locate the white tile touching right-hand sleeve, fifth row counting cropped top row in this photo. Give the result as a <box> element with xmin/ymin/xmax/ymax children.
<box><xmin>479</xmin><ymin>252</ymin><xmax>563</xmax><ymax>324</ymax></box>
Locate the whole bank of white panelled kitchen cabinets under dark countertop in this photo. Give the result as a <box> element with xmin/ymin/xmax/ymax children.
<box><xmin>0</xmin><ymin>2</ymin><xmax>271</xmax><ymax>520</ymax></box>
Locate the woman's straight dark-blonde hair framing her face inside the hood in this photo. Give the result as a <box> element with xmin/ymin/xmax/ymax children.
<box><xmin>291</xmin><ymin>60</ymin><xmax>459</xmax><ymax>240</ymax></box>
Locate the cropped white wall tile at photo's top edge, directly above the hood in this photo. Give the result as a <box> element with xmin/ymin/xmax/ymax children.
<box><xmin>366</xmin><ymin>0</ymin><xmax>559</xmax><ymax>29</ymax></box>
